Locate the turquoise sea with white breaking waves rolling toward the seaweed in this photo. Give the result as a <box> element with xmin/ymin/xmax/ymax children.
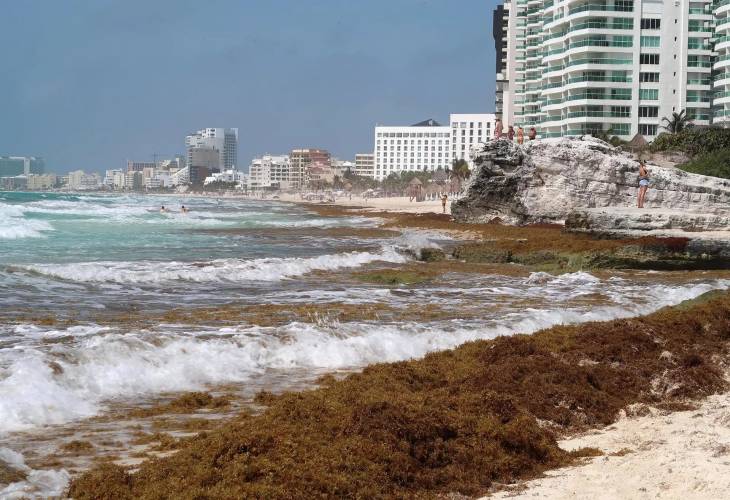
<box><xmin>0</xmin><ymin>192</ymin><xmax>730</xmax><ymax>498</ymax></box>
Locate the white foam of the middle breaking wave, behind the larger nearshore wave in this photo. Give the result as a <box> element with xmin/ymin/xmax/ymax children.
<box><xmin>21</xmin><ymin>247</ymin><xmax>407</xmax><ymax>284</ymax></box>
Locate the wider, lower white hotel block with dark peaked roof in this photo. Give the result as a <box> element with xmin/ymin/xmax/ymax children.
<box><xmin>373</xmin><ymin>120</ymin><xmax>452</xmax><ymax>180</ymax></box>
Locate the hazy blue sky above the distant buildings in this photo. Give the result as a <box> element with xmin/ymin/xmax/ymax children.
<box><xmin>0</xmin><ymin>0</ymin><xmax>499</xmax><ymax>173</ymax></box>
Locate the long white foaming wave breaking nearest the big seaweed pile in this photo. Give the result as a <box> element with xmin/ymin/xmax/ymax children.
<box><xmin>0</xmin><ymin>275</ymin><xmax>730</xmax><ymax>432</ymax></box>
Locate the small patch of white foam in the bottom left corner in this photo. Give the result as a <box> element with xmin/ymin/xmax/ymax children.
<box><xmin>0</xmin><ymin>448</ymin><xmax>71</xmax><ymax>500</ymax></box>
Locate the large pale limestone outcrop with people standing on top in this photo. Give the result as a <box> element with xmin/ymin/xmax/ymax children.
<box><xmin>452</xmin><ymin>137</ymin><xmax>730</xmax><ymax>224</ymax></box>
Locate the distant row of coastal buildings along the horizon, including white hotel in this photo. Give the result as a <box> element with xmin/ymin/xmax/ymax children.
<box><xmin>0</xmin><ymin>113</ymin><xmax>495</xmax><ymax>191</ymax></box>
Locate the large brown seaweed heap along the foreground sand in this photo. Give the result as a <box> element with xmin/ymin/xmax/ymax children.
<box><xmin>69</xmin><ymin>293</ymin><xmax>730</xmax><ymax>499</ymax></box>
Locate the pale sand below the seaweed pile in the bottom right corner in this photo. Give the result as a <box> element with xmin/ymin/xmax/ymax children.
<box><xmin>485</xmin><ymin>384</ymin><xmax>730</xmax><ymax>500</ymax></box>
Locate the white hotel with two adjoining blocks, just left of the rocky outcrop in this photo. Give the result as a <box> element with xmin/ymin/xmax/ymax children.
<box><xmin>373</xmin><ymin>114</ymin><xmax>495</xmax><ymax>180</ymax></box>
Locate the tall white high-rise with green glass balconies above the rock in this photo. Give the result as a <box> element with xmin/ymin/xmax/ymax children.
<box><xmin>493</xmin><ymin>0</ymin><xmax>712</xmax><ymax>140</ymax></box>
